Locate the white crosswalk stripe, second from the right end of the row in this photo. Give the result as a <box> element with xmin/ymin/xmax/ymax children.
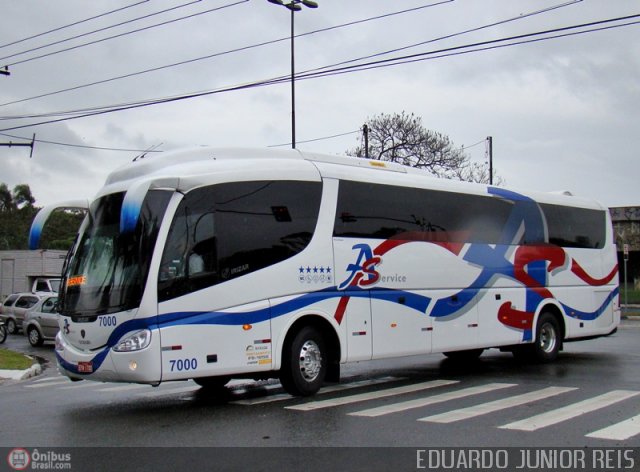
<box><xmin>500</xmin><ymin>390</ymin><xmax>640</xmax><ymax>431</ymax></box>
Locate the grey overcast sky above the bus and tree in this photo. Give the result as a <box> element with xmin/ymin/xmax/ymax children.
<box><xmin>0</xmin><ymin>0</ymin><xmax>640</xmax><ymax>206</ymax></box>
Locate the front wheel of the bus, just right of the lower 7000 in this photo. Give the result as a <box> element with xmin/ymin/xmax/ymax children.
<box><xmin>280</xmin><ymin>326</ymin><xmax>328</xmax><ymax>397</ymax></box>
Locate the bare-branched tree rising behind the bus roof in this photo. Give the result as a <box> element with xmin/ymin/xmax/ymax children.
<box><xmin>347</xmin><ymin>111</ymin><xmax>502</xmax><ymax>183</ymax></box>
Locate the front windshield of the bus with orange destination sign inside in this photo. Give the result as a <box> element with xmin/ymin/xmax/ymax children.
<box><xmin>59</xmin><ymin>190</ymin><xmax>171</xmax><ymax>316</ymax></box>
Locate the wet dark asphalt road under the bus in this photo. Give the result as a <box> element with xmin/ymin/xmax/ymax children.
<box><xmin>0</xmin><ymin>320</ymin><xmax>640</xmax><ymax>470</ymax></box>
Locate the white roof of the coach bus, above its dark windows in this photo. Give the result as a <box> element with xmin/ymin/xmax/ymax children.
<box><xmin>97</xmin><ymin>147</ymin><xmax>605</xmax><ymax>209</ymax></box>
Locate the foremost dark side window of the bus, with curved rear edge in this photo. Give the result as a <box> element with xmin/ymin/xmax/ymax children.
<box><xmin>158</xmin><ymin>181</ymin><xmax>322</xmax><ymax>301</ymax></box>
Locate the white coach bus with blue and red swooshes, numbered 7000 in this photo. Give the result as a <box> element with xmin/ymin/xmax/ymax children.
<box><xmin>30</xmin><ymin>148</ymin><xmax>620</xmax><ymax>395</ymax></box>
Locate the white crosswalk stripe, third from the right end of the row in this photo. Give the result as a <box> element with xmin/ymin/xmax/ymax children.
<box><xmin>418</xmin><ymin>387</ymin><xmax>577</xmax><ymax>423</ymax></box>
